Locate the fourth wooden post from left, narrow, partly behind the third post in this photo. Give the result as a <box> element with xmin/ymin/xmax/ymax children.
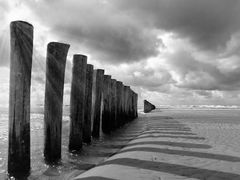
<box><xmin>83</xmin><ymin>64</ymin><xmax>93</xmax><ymax>143</ymax></box>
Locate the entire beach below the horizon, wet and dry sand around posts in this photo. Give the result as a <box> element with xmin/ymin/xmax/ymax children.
<box><xmin>0</xmin><ymin>108</ymin><xmax>240</xmax><ymax>180</ymax></box>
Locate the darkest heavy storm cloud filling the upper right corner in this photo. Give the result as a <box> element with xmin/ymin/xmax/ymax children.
<box><xmin>114</xmin><ymin>0</ymin><xmax>240</xmax><ymax>50</ymax></box>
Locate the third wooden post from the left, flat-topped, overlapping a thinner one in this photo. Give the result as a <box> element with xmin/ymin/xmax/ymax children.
<box><xmin>69</xmin><ymin>55</ymin><xmax>87</xmax><ymax>151</ymax></box>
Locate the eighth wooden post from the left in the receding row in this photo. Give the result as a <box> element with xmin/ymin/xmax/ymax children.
<box><xmin>116</xmin><ymin>81</ymin><xmax>123</xmax><ymax>128</ymax></box>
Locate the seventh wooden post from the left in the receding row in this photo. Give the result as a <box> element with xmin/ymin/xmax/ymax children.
<box><xmin>111</xmin><ymin>79</ymin><xmax>117</xmax><ymax>130</ymax></box>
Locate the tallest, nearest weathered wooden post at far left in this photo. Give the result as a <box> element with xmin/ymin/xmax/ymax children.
<box><xmin>8</xmin><ymin>21</ymin><xmax>33</xmax><ymax>176</ymax></box>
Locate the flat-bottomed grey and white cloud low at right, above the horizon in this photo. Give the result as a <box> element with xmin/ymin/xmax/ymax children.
<box><xmin>168</xmin><ymin>51</ymin><xmax>240</xmax><ymax>90</ymax></box>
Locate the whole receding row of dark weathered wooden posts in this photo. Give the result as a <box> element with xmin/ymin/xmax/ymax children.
<box><xmin>8</xmin><ymin>21</ymin><xmax>138</xmax><ymax>174</ymax></box>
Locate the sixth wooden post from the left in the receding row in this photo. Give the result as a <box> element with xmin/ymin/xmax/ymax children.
<box><xmin>102</xmin><ymin>75</ymin><xmax>111</xmax><ymax>133</ymax></box>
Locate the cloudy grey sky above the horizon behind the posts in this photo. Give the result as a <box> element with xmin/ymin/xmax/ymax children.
<box><xmin>0</xmin><ymin>0</ymin><xmax>240</xmax><ymax>107</ymax></box>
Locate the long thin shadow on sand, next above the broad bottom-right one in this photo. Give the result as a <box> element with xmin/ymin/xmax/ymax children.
<box><xmin>119</xmin><ymin>147</ymin><xmax>240</xmax><ymax>162</ymax></box>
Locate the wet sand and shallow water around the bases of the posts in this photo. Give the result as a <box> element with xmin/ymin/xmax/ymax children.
<box><xmin>0</xmin><ymin>113</ymin><xmax>146</xmax><ymax>180</ymax></box>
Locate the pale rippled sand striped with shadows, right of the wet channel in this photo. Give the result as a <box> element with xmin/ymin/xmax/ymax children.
<box><xmin>74</xmin><ymin>109</ymin><xmax>240</xmax><ymax>180</ymax></box>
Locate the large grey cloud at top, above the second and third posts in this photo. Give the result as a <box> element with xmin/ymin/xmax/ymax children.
<box><xmin>24</xmin><ymin>0</ymin><xmax>162</xmax><ymax>63</ymax></box>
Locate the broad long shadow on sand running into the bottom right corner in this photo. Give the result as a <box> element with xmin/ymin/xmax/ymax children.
<box><xmin>100</xmin><ymin>158</ymin><xmax>240</xmax><ymax>180</ymax></box>
